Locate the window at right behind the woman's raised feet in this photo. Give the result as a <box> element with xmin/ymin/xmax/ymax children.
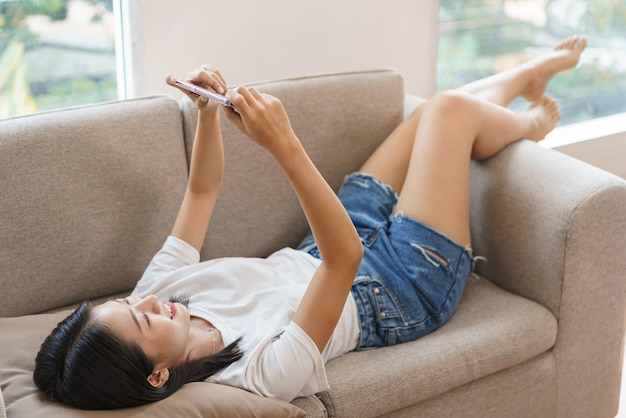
<box><xmin>437</xmin><ymin>0</ymin><xmax>626</xmax><ymax>130</ymax></box>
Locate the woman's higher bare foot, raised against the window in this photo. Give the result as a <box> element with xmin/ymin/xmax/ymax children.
<box><xmin>522</xmin><ymin>36</ymin><xmax>587</xmax><ymax>102</ymax></box>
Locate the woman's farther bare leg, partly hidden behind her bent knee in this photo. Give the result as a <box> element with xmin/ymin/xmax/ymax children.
<box><xmin>360</xmin><ymin>37</ymin><xmax>587</xmax><ymax>192</ymax></box>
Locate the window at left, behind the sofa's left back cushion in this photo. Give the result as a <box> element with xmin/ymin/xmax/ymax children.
<box><xmin>0</xmin><ymin>0</ymin><xmax>118</xmax><ymax>118</ymax></box>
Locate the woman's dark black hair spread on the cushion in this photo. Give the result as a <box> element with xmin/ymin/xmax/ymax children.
<box><xmin>33</xmin><ymin>302</ymin><xmax>243</xmax><ymax>409</ymax></box>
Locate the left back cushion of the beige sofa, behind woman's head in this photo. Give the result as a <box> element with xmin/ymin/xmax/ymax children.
<box><xmin>0</xmin><ymin>97</ymin><xmax>187</xmax><ymax>317</ymax></box>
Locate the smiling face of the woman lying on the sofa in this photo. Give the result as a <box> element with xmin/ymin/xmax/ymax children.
<box><xmin>93</xmin><ymin>295</ymin><xmax>190</xmax><ymax>369</ymax></box>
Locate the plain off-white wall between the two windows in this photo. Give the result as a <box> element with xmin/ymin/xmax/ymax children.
<box><xmin>127</xmin><ymin>0</ymin><xmax>439</xmax><ymax>97</ymax></box>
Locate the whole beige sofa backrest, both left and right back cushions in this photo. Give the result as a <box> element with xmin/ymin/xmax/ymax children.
<box><xmin>0</xmin><ymin>70</ymin><xmax>404</xmax><ymax>317</ymax></box>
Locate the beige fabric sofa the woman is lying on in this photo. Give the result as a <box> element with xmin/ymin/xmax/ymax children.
<box><xmin>0</xmin><ymin>70</ymin><xmax>626</xmax><ymax>418</ymax></box>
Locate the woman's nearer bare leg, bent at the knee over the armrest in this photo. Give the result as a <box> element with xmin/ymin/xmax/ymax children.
<box><xmin>396</xmin><ymin>91</ymin><xmax>560</xmax><ymax>245</ymax></box>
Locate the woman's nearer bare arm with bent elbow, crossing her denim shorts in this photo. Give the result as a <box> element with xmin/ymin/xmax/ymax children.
<box><xmin>227</xmin><ymin>87</ymin><xmax>363</xmax><ymax>351</ymax></box>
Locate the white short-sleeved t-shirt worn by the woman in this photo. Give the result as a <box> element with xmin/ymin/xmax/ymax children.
<box><xmin>133</xmin><ymin>236</ymin><xmax>359</xmax><ymax>401</ymax></box>
